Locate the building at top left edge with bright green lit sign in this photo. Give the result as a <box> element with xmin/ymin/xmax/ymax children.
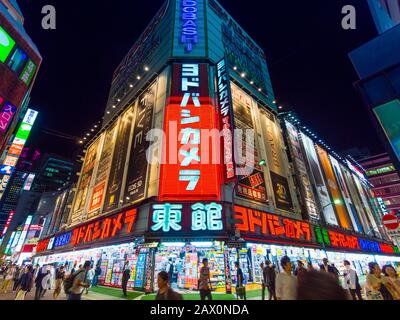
<box><xmin>0</xmin><ymin>0</ymin><xmax>42</xmax><ymax>160</ymax></box>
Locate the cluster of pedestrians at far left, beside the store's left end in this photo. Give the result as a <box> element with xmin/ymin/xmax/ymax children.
<box><xmin>0</xmin><ymin>261</ymin><xmax>101</xmax><ymax>300</ymax></box>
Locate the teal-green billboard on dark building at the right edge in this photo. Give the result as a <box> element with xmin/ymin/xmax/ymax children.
<box><xmin>373</xmin><ymin>99</ymin><xmax>400</xmax><ymax>160</ymax></box>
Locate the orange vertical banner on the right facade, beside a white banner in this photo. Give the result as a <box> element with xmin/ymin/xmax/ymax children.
<box><xmin>316</xmin><ymin>145</ymin><xmax>352</xmax><ymax>229</ymax></box>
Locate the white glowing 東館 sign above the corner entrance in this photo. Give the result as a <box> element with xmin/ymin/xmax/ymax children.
<box><xmin>150</xmin><ymin>202</ymin><xmax>224</xmax><ymax>233</ymax></box>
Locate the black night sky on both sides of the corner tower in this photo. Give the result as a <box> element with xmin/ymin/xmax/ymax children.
<box><xmin>19</xmin><ymin>0</ymin><xmax>383</xmax><ymax>157</ymax></box>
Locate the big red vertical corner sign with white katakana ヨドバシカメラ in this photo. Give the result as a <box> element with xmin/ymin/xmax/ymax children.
<box><xmin>159</xmin><ymin>63</ymin><xmax>220</xmax><ymax>201</ymax></box>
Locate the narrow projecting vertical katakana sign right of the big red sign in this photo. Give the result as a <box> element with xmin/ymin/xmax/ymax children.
<box><xmin>217</xmin><ymin>59</ymin><xmax>236</xmax><ymax>183</ymax></box>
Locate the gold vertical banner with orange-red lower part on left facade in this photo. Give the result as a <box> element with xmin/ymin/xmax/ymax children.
<box><xmin>88</xmin><ymin>120</ymin><xmax>118</xmax><ymax>219</ymax></box>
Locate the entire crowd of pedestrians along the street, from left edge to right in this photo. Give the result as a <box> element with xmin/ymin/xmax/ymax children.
<box><xmin>0</xmin><ymin>256</ymin><xmax>400</xmax><ymax>300</ymax></box>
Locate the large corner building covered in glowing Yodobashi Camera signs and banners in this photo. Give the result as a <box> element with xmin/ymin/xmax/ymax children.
<box><xmin>35</xmin><ymin>0</ymin><xmax>400</xmax><ymax>292</ymax></box>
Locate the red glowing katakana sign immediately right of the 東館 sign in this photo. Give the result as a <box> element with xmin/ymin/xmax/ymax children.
<box><xmin>234</xmin><ymin>206</ymin><xmax>312</xmax><ymax>243</ymax></box>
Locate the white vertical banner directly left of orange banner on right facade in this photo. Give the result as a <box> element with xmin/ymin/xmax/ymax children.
<box><xmin>300</xmin><ymin>133</ymin><xmax>339</xmax><ymax>226</ymax></box>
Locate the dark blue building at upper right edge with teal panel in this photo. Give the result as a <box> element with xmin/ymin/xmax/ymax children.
<box><xmin>349</xmin><ymin>0</ymin><xmax>400</xmax><ymax>169</ymax></box>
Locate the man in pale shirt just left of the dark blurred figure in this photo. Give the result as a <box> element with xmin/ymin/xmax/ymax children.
<box><xmin>276</xmin><ymin>256</ymin><xmax>297</xmax><ymax>300</ymax></box>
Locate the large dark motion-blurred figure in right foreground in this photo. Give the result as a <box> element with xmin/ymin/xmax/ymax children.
<box><xmin>297</xmin><ymin>270</ymin><xmax>348</xmax><ymax>300</ymax></box>
